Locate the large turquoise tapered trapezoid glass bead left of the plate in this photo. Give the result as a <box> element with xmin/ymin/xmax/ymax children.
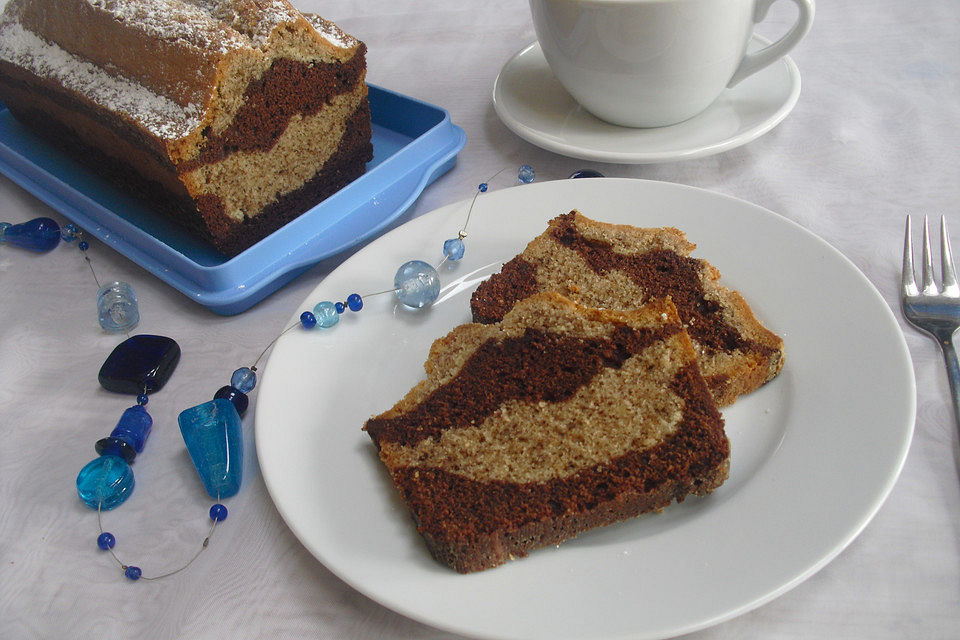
<box><xmin>177</xmin><ymin>398</ymin><xmax>243</xmax><ymax>500</ymax></box>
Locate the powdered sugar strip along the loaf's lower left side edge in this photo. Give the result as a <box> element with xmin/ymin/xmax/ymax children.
<box><xmin>0</xmin><ymin>23</ymin><xmax>201</xmax><ymax>139</ymax></box>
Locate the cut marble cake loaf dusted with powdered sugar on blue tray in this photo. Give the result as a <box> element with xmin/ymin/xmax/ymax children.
<box><xmin>0</xmin><ymin>0</ymin><xmax>373</xmax><ymax>256</ymax></box>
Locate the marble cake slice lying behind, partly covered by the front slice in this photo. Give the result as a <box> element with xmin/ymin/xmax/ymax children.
<box><xmin>470</xmin><ymin>211</ymin><xmax>783</xmax><ymax>406</ymax></box>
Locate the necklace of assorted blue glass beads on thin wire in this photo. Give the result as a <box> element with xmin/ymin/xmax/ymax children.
<box><xmin>0</xmin><ymin>165</ymin><xmax>540</xmax><ymax>581</ymax></box>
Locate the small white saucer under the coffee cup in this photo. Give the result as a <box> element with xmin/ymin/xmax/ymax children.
<box><xmin>493</xmin><ymin>36</ymin><xmax>800</xmax><ymax>164</ymax></box>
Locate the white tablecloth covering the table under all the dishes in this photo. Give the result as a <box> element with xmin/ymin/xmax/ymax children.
<box><xmin>0</xmin><ymin>0</ymin><xmax>960</xmax><ymax>640</ymax></box>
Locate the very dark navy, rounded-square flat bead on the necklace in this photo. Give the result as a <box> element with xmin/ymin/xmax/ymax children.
<box><xmin>98</xmin><ymin>334</ymin><xmax>180</xmax><ymax>395</ymax></box>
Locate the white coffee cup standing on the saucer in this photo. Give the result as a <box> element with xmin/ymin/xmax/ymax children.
<box><xmin>530</xmin><ymin>0</ymin><xmax>814</xmax><ymax>127</ymax></box>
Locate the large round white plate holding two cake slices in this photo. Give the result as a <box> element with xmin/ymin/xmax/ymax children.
<box><xmin>256</xmin><ymin>178</ymin><xmax>915</xmax><ymax>639</ymax></box>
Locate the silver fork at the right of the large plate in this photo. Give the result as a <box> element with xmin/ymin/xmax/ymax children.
<box><xmin>900</xmin><ymin>216</ymin><xmax>960</xmax><ymax>428</ymax></box>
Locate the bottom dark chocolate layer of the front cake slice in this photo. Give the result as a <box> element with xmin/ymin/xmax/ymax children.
<box><xmin>394</xmin><ymin>366</ymin><xmax>730</xmax><ymax>573</ymax></box>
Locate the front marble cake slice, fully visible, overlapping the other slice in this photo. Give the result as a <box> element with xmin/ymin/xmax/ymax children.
<box><xmin>364</xmin><ymin>292</ymin><xmax>730</xmax><ymax>573</ymax></box>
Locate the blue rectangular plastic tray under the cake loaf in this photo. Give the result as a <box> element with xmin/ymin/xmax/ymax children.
<box><xmin>0</xmin><ymin>85</ymin><xmax>467</xmax><ymax>315</ymax></box>
